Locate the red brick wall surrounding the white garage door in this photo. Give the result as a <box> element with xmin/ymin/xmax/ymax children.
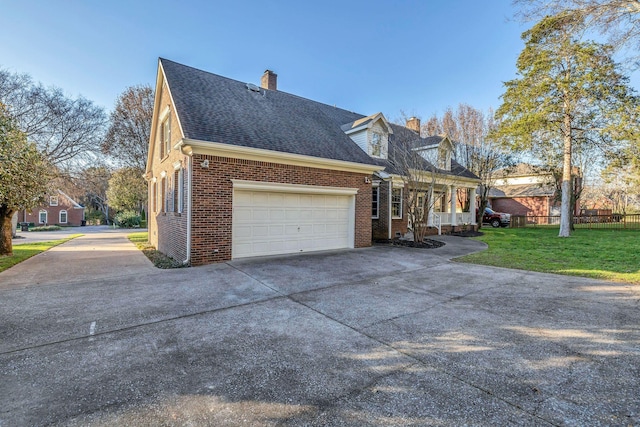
<box><xmin>191</xmin><ymin>154</ymin><xmax>371</xmax><ymax>265</ymax></box>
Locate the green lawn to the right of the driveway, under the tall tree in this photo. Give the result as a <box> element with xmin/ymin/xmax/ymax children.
<box><xmin>456</xmin><ymin>227</ymin><xmax>640</xmax><ymax>284</ymax></box>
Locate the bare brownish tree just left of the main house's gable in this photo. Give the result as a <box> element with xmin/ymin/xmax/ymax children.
<box><xmin>101</xmin><ymin>85</ymin><xmax>153</xmax><ymax>175</ymax></box>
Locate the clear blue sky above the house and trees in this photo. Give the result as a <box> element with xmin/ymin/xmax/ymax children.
<box><xmin>0</xmin><ymin>0</ymin><xmax>636</xmax><ymax>120</ymax></box>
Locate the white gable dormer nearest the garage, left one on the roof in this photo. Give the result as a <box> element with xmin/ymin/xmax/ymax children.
<box><xmin>341</xmin><ymin>113</ymin><xmax>393</xmax><ymax>159</ymax></box>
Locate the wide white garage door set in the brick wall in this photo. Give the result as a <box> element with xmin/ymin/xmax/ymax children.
<box><xmin>232</xmin><ymin>180</ymin><xmax>357</xmax><ymax>259</ymax></box>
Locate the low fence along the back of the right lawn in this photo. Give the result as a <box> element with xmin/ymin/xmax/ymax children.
<box><xmin>511</xmin><ymin>214</ymin><xmax>640</xmax><ymax>230</ymax></box>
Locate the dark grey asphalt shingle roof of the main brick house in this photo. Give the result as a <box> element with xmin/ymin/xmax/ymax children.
<box><xmin>160</xmin><ymin>58</ymin><xmax>476</xmax><ymax>178</ymax></box>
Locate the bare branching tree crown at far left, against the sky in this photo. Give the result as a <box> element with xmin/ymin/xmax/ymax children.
<box><xmin>0</xmin><ymin>70</ymin><xmax>105</xmax><ymax>168</ymax></box>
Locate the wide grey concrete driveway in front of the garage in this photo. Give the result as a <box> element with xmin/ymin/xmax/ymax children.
<box><xmin>0</xmin><ymin>232</ymin><xmax>640</xmax><ymax>427</ymax></box>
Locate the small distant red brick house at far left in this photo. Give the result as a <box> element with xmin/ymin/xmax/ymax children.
<box><xmin>18</xmin><ymin>190</ymin><xmax>84</xmax><ymax>226</ymax></box>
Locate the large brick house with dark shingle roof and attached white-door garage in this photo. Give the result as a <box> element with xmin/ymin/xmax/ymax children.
<box><xmin>146</xmin><ymin>59</ymin><xmax>478</xmax><ymax>265</ymax></box>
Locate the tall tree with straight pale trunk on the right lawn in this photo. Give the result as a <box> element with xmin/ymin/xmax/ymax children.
<box><xmin>494</xmin><ymin>14</ymin><xmax>638</xmax><ymax>237</ymax></box>
